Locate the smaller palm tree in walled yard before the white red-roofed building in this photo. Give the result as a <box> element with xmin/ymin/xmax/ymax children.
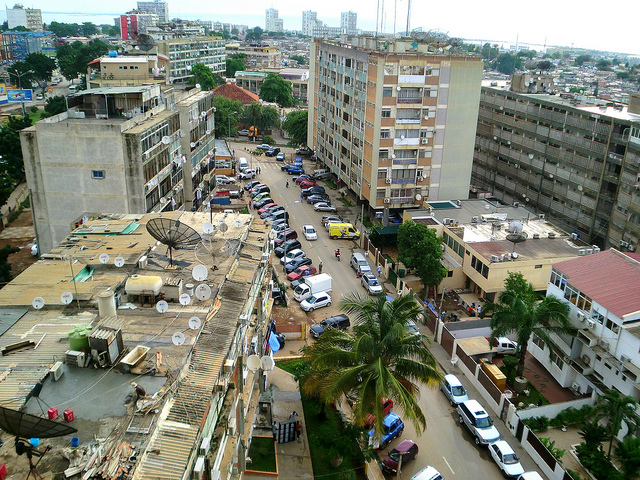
<box><xmin>483</xmin><ymin>272</ymin><xmax>575</xmax><ymax>377</ymax></box>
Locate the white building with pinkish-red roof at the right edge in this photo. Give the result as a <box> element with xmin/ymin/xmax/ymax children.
<box><xmin>529</xmin><ymin>249</ymin><xmax>640</xmax><ymax>400</ymax></box>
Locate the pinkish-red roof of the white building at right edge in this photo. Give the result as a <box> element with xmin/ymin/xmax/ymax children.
<box><xmin>553</xmin><ymin>249</ymin><xmax>640</xmax><ymax>319</ymax></box>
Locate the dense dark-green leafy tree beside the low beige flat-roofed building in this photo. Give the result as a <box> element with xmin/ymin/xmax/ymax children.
<box><xmin>398</xmin><ymin>222</ymin><xmax>447</xmax><ymax>298</ymax></box>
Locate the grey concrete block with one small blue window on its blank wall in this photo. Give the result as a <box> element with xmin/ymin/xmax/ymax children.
<box><xmin>20</xmin><ymin>85</ymin><xmax>215</xmax><ymax>253</ymax></box>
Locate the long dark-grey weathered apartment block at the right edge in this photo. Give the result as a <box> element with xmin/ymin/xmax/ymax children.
<box><xmin>472</xmin><ymin>87</ymin><xmax>640</xmax><ymax>250</ymax></box>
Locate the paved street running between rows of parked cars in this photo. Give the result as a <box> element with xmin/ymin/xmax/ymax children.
<box><xmin>232</xmin><ymin>144</ymin><xmax>536</xmax><ymax>480</ymax></box>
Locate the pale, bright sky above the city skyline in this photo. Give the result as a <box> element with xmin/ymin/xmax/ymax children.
<box><xmin>5</xmin><ymin>0</ymin><xmax>640</xmax><ymax>55</ymax></box>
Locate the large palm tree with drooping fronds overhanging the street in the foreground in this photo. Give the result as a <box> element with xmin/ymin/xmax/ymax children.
<box><xmin>302</xmin><ymin>294</ymin><xmax>442</xmax><ymax>435</ymax></box>
